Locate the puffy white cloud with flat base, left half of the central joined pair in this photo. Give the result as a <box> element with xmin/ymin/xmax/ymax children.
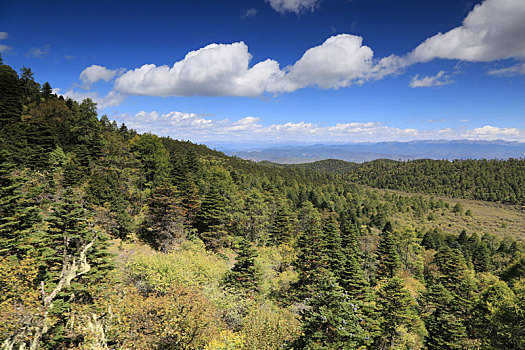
<box><xmin>115</xmin><ymin>42</ymin><xmax>283</xmax><ymax>97</ymax></box>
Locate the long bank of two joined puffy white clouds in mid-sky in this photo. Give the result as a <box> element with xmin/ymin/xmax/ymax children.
<box><xmin>115</xmin><ymin>34</ymin><xmax>406</xmax><ymax>97</ymax></box>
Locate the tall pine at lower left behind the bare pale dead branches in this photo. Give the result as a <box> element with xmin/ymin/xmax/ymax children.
<box><xmin>29</xmin><ymin>190</ymin><xmax>113</xmax><ymax>349</ymax></box>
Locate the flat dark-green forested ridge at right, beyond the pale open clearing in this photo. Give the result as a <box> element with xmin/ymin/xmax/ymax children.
<box><xmin>348</xmin><ymin>158</ymin><xmax>525</xmax><ymax>205</ymax></box>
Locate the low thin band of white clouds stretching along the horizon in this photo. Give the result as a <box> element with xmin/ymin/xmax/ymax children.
<box><xmin>109</xmin><ymin>111</ymin><xmax>525</xmax><ymax>142</ymax></box>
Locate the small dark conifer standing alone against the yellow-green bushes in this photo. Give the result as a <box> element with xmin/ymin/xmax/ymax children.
<box><xmin>225</xmin><ymin>238</ymin><xmax>260</xmax><ymax>295</ymax></box>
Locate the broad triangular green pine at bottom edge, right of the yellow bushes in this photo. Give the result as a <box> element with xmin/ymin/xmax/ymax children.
<box><xmin>291</xmin><ymin>271</ymin><xmax>370</xmax><ymax>350</ymax></box>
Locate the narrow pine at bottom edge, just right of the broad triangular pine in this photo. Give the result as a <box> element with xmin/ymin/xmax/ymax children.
<box><xmin>374</xmin><ymin>277</ymin><xmax>425</xmax><ymax>349</ymax></box>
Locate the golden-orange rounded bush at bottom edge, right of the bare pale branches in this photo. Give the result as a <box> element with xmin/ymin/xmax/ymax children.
<box><xmin>107</xmin><ymin>287</ymin><xmax>221</xmax><ymax>350</ymax></box>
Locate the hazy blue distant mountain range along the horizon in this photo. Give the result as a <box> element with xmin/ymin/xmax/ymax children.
<box><xmin>224</xmin><ymin>140</ymin><xmax>525</xmax><ymax>164</ymax></box>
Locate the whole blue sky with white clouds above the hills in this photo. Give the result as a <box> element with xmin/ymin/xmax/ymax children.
<box><xmin>0</xmin><ymin>0</ymin><xmax>525</xmax><ymax>143</ymax></box>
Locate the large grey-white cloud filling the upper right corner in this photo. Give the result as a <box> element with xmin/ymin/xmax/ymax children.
<box><xmin>410</xmin><ymin>0</ymin><xmax>525</xmax><ymax>62</ymax></box>
